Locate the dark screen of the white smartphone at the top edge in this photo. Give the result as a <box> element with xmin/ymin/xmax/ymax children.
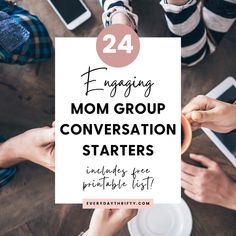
<box><xmin>50</xmin><ymin>0</ymin><xmax>86</xmax><ymax>24</ymax></box>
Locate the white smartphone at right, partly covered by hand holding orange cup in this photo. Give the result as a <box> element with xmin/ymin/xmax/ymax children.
<box><xmin>202</xmin><ymin>77</ymin><xmax>236</xmax><ymax>167</ymax></box>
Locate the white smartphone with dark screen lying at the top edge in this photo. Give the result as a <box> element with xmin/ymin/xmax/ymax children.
<box><xmin>48</xmin><ymin>0</ymin><xmax>91</xmax><ymax>30</ymax></box>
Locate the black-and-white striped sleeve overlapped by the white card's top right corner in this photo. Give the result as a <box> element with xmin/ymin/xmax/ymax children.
<box><xmin>160</xmin><ymin>0</ymin><xmax>209</xmax><ymax>66</ymax></box>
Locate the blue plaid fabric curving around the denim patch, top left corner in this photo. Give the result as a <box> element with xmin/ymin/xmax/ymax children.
<box><xmin>0</xmin><ymin>0</ymin><xmax>54</xmax><ymax>65</ymax></box>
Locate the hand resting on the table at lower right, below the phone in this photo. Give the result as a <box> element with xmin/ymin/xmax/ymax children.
<box><xmin>181</xmin><ymin>154</ymin><xmax>236</xmax><ymax>210</ymax></box>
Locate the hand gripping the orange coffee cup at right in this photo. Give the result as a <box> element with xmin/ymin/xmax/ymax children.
<box><xmin>182</xmin><ymin>95</ymin><xmax>236</xmax><ymax>133</ymax></box>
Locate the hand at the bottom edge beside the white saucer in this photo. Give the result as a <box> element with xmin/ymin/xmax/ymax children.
<box><xmin>87</xmin><ymin>209</ymin><xmax>138</xmax><ymax>236</ymax></box>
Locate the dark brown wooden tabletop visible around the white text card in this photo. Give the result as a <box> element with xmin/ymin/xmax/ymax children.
<box><xmin>0</xmin><ymin>0</ymin><xmax>236</xmax><ymax>236</ymax></box>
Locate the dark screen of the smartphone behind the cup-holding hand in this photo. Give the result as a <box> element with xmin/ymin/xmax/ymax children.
<box><xmin>214</xmin><ymin>86</ymin><xmax>236</xmax><ymax>158</ymax></box>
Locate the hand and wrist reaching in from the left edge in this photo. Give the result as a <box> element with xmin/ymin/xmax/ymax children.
<box><xmin>0</xmin><ymin>125</ymin><xmax>55</xmax><ymax>171</ymax></box>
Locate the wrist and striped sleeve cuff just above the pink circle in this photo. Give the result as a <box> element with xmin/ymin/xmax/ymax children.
<box><xmin>99</xmin><ymin>0</ymin><xmax>138</xmax><ymax>29</ymax></box>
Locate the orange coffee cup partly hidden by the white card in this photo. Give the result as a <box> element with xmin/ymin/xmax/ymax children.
<box><xmin>181</xmin><ymin>114</ymin><xmax>192</xmax><ymax>155</ymax></box>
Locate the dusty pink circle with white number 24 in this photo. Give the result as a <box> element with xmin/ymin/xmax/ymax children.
<box><xmin>96</xmin><ymin>24</ymin><xmax>140</xmax><ymax>67</ymax></box>
